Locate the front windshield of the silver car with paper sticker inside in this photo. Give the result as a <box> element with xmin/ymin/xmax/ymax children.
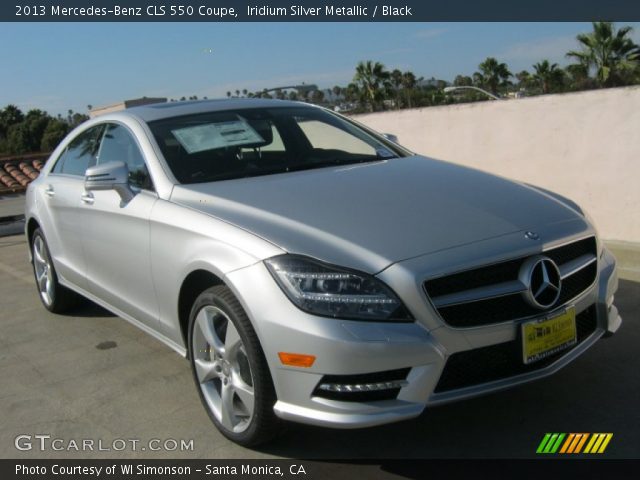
<box><xmin>149</xmin><ymin>107</ymin><xmax>406</xmax><ymax>183</ymax></box>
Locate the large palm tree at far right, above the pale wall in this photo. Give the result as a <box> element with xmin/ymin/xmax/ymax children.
<box><xmin>567</xmin><ymin>22</ymin><xmax>640</xmax><ymax>87</ymax></box>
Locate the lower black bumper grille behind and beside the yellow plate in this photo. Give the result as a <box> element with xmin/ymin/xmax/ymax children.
<box><xmin>434</xmin><ymin>305</ymin><xmax>597</xmax><ymax>393</ymax></box>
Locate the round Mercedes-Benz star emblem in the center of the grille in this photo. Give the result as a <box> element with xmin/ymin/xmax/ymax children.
<box><xmin>519</xmin><ymin>255</ymin><xmax>562</xmax><ymax>309</ymax></box>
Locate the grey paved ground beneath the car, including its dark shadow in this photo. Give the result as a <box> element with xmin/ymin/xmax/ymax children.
<box><xmin>0</xmin><ymin>232</ymin><xmax>640</xmax><ymax>461</ymax></box>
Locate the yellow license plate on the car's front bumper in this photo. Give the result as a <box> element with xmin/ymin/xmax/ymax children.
<box><xmin>522</xmin><ymin>307</ymin><xmax>577</xmax><ymax>364</ymax></box>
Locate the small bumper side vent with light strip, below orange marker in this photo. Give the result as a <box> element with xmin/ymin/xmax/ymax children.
<box><xmin>313</xmin><ymin>368</ymin><xmax>411</xmax><ymax>402</ymax></box>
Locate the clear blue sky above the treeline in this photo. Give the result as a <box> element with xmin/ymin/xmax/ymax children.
<box><xmin>0</xmin><ymin>23</ymin><xmax>640</xmax><ymax>114</ymax></box>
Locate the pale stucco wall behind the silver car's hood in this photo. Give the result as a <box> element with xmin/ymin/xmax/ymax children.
<box><xmin>356</xmin><ymin>87</ymin><xmax>640</xmax><ymax>242</ymax></box>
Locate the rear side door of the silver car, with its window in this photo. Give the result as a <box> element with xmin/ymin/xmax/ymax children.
<box><xmin>38</xmin><ymin>125</ymin><xmax>104</xmax><ymax>290</ymax></box>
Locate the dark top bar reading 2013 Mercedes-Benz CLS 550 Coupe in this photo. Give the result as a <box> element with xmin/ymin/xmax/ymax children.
<box><xmin>0</xmin><ymin>0</ymin><xmax>640</xmax><ymax>22</ymax></box>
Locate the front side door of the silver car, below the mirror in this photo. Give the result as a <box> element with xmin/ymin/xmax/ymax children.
<box><xmin>83</xmin><ymin>123</ymin><xmax>158</xmax><ymax>326</ymax></box>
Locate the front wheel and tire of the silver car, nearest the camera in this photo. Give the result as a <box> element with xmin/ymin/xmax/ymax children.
<box><xmin>189</xmin><ymin>286</ymin><xmax>281</xmax><ymax>447</ymax></box>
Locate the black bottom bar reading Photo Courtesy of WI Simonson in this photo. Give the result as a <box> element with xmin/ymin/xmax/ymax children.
<box><xmin>5</xmin><ymin>459</ymin><xmax>638</xmax><ymax>480</ymax></box>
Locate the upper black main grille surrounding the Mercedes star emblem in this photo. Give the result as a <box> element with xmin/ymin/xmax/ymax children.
<box><xmin>424</xmin><ymin>237</ymin><xmax>598</xmax><ymax>328</ymax></box>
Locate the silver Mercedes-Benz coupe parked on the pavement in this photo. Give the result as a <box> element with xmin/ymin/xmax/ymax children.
<box><xmin>26</xmin><ymin>99</ymin><xmax>621</xmax><ymax>445</ymax></box>
